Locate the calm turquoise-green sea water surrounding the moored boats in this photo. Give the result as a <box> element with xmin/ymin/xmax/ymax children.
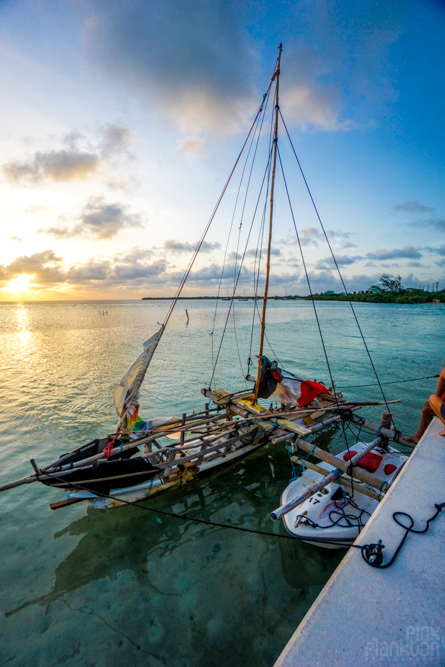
<box><xmin>0</xmin><ymin>300</ymin><xmax>445</xmax><ymax>667</ymax></box>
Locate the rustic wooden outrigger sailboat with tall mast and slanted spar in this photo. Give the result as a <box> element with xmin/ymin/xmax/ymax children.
<box><xmin>0</xmin><ymin>45</ymin><xmax>412</xmax><ymax>520</ymax></box>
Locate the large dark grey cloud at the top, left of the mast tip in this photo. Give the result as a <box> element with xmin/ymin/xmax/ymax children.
<box><xmin>85</xmin><ymin>0</ymin><xmax>253</xmax><ymax>137</ymax></box>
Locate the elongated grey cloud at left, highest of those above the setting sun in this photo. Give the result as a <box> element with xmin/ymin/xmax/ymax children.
<box><xmin>3</xmin><ymin>124</ymin><xmax>131</xmax><ymax>185</ymax></box>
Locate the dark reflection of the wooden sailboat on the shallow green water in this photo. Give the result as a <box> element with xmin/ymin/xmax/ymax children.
<box><xmin>6</xmin><ymin>438</ymin><xmax>341</xmax><ymax>617</ymax></box>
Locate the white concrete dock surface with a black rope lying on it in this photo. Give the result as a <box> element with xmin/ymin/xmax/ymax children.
<box><xmin>275</xmin><ymin>418</ymin><xmax>445</xmax><ymax>667</ymax></box>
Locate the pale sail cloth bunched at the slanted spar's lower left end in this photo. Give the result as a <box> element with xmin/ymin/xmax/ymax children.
<box><xmin>113</xmin><ymin>325</ymin><xmax>164</xmax><ymax>417</ymax></box>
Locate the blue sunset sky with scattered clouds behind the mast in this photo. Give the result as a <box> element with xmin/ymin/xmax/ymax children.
<box><xmin>0</xmin><ymin>0</ymin><xmax>445</xmax><ymax>301</ymax></box>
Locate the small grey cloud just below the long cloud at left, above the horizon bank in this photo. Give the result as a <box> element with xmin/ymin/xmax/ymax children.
<box><xmin>43</xmin><ymin>197</ymin><xmax>143</xmax><ymax>240</ymax></box>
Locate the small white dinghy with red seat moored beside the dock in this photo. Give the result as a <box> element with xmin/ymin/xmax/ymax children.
<box><xmin>272</xmin><ymin>442</ymin><xmax>408</xmax><ymax>549</ymax></box>
